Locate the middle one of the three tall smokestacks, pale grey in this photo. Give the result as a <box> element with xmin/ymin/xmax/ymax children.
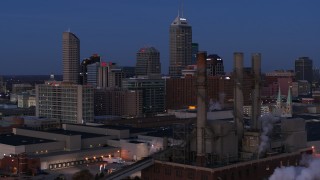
<box><xmin>233</xmin><ymin>52</ymin><xmax>243</xmax><ymax>143</ymax></box>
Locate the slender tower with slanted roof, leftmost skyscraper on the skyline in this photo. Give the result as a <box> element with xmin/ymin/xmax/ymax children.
<box><xmin>62</xmin><ymin>32</ymin><xmax>80</xmax><ymax>83</ymax></box>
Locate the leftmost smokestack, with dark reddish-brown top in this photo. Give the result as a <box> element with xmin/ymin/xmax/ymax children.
<box><xmin>197</xmin><ymin>52</ymin><xmax>207</xmax><ymax>166</ymax></box>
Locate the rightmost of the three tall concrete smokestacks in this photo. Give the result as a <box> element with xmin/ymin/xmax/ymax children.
<box><xmin>251</xmin><ymin>53</ymin><xmax>261</xmax><ymax>130</ymax></box>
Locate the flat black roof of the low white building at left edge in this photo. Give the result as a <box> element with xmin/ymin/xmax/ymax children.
<box><xmin>0</xmin><ymin>134</ymin><xmax>56</xmax><ymax>146</ymax></box>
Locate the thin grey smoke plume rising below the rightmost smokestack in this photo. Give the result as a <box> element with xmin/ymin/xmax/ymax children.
<box><xmin>259</xmin><ymin>114</ymin><xmax>279</xmax><ymax>154</ymax></box>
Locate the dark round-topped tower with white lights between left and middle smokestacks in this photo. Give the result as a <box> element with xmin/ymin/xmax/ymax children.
<box><xmin>207</xmin><ymin>54</ymin><xmax>225</xmax><ymax>76</ymax></box>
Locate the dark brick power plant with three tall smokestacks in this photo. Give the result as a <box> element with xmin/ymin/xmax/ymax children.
<box><xmin>141</xmin><ymin>52</ymin><xmax>313</xmax><ymax>180</ymax></box>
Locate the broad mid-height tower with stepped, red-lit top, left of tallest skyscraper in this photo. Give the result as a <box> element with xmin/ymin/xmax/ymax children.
<box><xmin>136</xmin><ymin>47</ymin><xmax>161</xmax><ymax>76</ymax></box>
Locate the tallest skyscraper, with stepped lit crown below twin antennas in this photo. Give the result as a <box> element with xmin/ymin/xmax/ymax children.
<box><xmin>169</xmin><ymin>15</ymin><xmax>192</xmax><ymax>77</ymax></box>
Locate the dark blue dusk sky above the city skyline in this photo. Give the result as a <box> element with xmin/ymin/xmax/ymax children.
<box><xmin>0</xmin><ymin>0</ymin><xmax>320</xmax><ymax>75</ymax></box>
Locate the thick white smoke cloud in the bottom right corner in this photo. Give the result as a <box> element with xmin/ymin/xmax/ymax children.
<box><xmin>269</xmin><ymin>155</ymin><xmax>320</xmax><ymax>180</ymax></box>
